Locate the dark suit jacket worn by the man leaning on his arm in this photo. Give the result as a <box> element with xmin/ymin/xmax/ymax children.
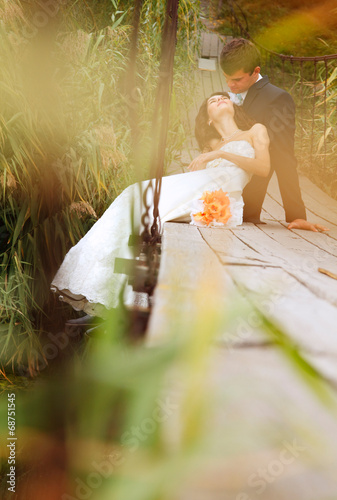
<box><xmin>242</xmin><ymin>76</ymin><xmax>306</xmax><ymax>222</ymax></box>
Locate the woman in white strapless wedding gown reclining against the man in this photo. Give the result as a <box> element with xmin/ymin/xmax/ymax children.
<box><xmin>51</xmin><ymin>92</ymin><xmax>270</xmax><ymax>316</ymax></box>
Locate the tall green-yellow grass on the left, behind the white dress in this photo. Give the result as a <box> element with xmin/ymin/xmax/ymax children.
<box><xmin>0</xmin><ymin>0</ymin><xmax>198</xmax><ymax>373</ymax></box>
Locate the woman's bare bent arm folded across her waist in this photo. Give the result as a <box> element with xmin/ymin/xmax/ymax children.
<box><xmin>188</xmin><ymin>123</ymin><xmax>270</xmax><ymax>177</ymax></box>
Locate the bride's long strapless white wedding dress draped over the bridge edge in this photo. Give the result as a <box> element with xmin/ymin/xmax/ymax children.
<box><xmin>51</xmin><ymin>140</ymin><xmax>254</xmax><ymax>316</ymax></box>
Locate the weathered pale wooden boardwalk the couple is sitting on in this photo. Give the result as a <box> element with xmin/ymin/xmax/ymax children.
<box><xmin>147</xmin><ymin>30</ymin><xmax>337</xmax><ymax>500</ymax></box>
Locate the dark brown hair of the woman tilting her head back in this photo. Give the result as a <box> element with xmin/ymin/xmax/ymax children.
<box><xmin>195</xmin><ymin>91</ymin><xmax>256</xmax><ymax>151</ymax></box>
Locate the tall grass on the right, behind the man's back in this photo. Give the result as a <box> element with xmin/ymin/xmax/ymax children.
<box><xmin>255</xmin><ymin>51</ymin><xmax>337</xmax><ymax>198</ymax></box>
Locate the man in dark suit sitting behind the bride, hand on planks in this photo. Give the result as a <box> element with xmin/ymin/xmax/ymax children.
<box><xmin>220</xmin><ymin>38</ymin><xmax>327</xmax><ymax>231</ymax></box>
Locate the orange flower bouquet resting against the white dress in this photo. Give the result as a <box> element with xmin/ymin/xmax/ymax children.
<box><xmin>191</xmin><ymin>189</ymin><xmax>232</xmax><ymax>226</ymax></box>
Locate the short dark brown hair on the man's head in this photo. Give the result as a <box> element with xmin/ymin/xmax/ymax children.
<box><xmin>220</xmin><ymin>38</ymin><xmax>261</xmax><ymax>75</ymax></box>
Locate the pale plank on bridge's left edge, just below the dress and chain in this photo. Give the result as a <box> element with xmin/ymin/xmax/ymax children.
<box><xmin>147</xmin><ymin>223</ymin><xmax>230</xmax><ymax>345</ymax></box>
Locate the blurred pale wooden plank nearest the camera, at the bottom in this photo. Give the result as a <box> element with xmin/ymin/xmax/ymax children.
<box><xmin>168</xmin><ymin>348</ymin><xmax>337</xmax><ymax>500</ymax></box>
